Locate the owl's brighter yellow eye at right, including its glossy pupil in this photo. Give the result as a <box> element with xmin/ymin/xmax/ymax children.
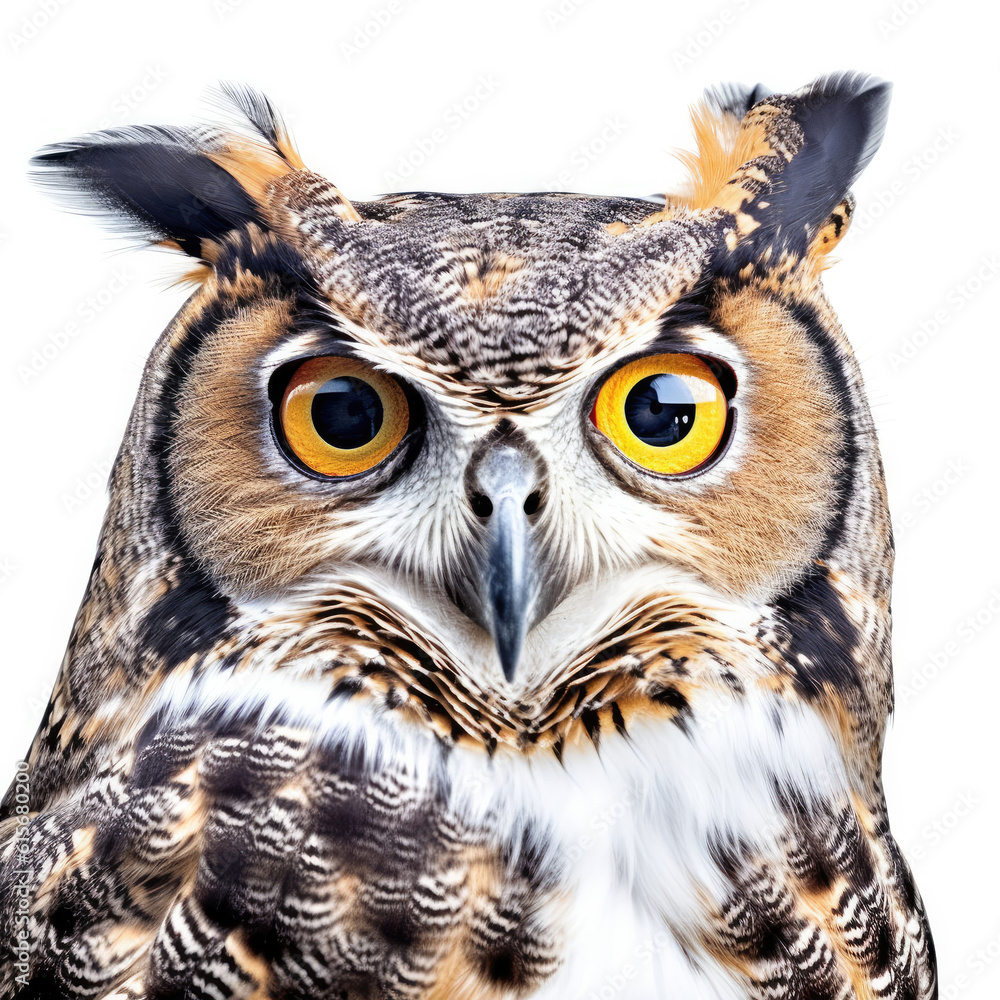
<box><xmin>592</xmin><ymin>354</ymin><xmax>727</xmax><ymax>475</ymax></box>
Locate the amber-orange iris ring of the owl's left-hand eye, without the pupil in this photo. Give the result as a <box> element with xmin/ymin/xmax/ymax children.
<box><xmin>279</xmin><ymin>356</ymin><xmax>410</xmax><ymax>476</ymax></box>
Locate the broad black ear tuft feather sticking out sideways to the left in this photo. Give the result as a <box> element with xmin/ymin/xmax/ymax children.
<box><xmin>31</xmin><ymin>126</ymin><xmax>259</xmax><ymax>257</ymax></box>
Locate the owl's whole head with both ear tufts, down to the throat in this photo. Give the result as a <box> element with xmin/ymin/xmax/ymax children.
<box><xmin>35</xmin><ymin>74</ymin><xmax>891</xmax><ymax>745</ymax></box>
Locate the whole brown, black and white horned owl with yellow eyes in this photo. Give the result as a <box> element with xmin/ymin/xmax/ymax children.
<box><xmin>0</xmin><ymin>74</ymin><xmax>937</xmax><ymax>1000</ymax></box>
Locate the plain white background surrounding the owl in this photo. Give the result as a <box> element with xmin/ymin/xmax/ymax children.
<box><xmin>0</xmin><ymin>0</ymin><xmax>1000</xmax><ymax>1000</ymax></box>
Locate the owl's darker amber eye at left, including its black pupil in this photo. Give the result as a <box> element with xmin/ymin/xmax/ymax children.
<box><xmin>279</xmin><ymin>357</ymin><xmax>410</xmax><ymax>476</ymax></box>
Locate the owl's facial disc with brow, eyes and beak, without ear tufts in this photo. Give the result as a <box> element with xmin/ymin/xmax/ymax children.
<box><xmin>164</xmin><ymin>203</ymin><xmax>848</xmax><ymax>681</ymax></box>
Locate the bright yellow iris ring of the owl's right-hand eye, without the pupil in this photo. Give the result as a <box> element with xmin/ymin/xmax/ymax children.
<box><xmin>594</xmin><ymin>354</ymin><xmax>729</xmax><ymax>475</ymax></box>
